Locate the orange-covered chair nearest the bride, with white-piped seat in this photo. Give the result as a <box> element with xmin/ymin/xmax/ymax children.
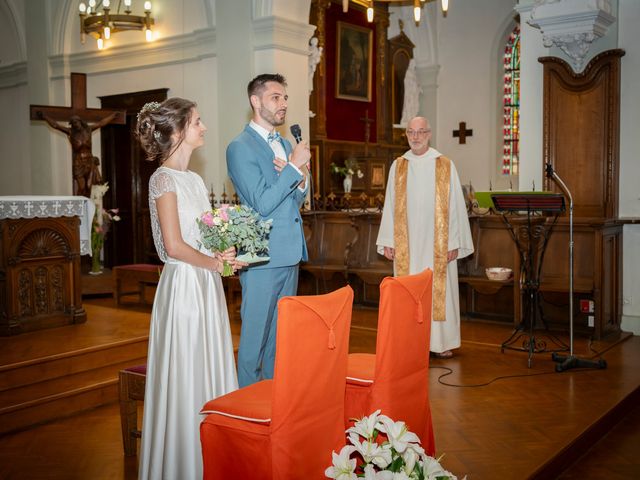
<box><xmin>200</xmin><ymin>286</ymin><xmax>353</xmax><ymax>480</ymax></box>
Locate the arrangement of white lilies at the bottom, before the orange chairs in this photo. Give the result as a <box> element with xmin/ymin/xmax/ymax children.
<box><xmin>324</xmin><ymin>410</ymin><xmax>456</xmax><ymax>480</ymax></box>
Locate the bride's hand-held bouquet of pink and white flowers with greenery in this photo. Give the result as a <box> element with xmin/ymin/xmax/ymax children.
<box><xmin>196</xmin><ymin>204</ymin><xmax>273</xmax><ymax>277</ymax></box>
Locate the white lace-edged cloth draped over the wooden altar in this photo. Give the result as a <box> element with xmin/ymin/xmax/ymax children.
<box><xmin>0</xmin><ymin>195</ymin><xmax>96</xmax><ymax>255</ymax></box>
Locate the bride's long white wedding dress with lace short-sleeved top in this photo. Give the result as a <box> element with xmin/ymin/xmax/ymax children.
<box><xmin>138</xmin><ymin>167</ymin><xmax>238</xmax><ymax>480</ymax></box>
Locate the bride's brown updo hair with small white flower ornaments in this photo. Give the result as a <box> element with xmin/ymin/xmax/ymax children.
<box><xmin>136</xmin><ymin>97</ymin><xmax>196</xmax><ymax>164</ymax></box>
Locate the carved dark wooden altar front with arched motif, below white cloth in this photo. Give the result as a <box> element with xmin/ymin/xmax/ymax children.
<box><xmin>0</xmin><ymin>217</ymin><xmax>86</xmax><ymax>335</ymax></box>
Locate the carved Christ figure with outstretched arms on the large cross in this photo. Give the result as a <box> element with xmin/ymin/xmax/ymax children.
<box><xmin>38</xmin><ymin>112</ymin><xmax>118</xmax><ymax>197</ymax></box>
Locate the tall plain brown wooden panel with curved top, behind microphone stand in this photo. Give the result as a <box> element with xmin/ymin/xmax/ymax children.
<box><xmin>540</xmin><ymin>50</ymin><xmax>624</xmax><ymax>218</ymax></box>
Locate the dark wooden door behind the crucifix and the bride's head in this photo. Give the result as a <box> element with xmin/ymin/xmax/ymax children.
<box><xmin>100</xmin><ymin>88</ymin><xmax>168</xmax><ymax>267</ymax></box>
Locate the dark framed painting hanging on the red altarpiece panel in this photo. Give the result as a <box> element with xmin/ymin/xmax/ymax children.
<box><xmin>336</xmin><ymin>22</ymin><xmax>373</xmax><ymax>102</ymax></box>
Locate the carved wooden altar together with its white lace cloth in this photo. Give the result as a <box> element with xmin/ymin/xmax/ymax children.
<box><xmin>0</xmin><ymin>197</ymin><xmax>95</xmax><ymax>336</ymax></box>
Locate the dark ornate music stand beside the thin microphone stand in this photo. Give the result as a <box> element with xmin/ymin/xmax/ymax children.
<box><xmin>491</xmin><ymin>192</ymin><xmax>569</xmax><ymax>368</ymax></box>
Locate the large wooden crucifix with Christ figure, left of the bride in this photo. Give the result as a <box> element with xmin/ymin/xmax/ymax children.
<box><xmin>30</xmin><ymin>73</ymin><xmax>127</xmax><ymax>197</ymax></box>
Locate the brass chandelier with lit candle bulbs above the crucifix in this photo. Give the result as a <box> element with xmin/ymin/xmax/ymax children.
<box><xmin>78</xmin><ymin>0</ymin><xmax>153</xmax><ymax>50</ymax></box>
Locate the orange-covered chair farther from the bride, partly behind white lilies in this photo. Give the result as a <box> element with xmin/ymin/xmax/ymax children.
<box><xmin>345</xmin><ymin>269</ymin><xmax>435</xmax><ymax>455</ymax></box>
